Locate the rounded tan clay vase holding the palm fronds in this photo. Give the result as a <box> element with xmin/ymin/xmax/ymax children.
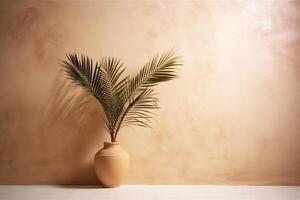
<box><xmin>94</xmin><ymin>142</ymin><xmax>129</xmax><ymax>187</ymax></box>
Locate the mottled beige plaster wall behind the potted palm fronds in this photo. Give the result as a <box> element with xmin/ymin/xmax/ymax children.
<box><xmin>0</xmin><ymin>0</ymin><xmax>300</xmax><ymax>184</ymax></box>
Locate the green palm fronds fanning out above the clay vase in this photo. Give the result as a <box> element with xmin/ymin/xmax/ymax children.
<box><xmin>62</xmin><ymin>51</ymin><xmax>182</xmax><ymax>142</ymax></box>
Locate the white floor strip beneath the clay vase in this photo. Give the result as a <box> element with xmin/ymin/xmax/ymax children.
<box><xmin>0</xmin><ymin>185</ymin><xmax>300</xmax><ymax>200</ymax></box>
